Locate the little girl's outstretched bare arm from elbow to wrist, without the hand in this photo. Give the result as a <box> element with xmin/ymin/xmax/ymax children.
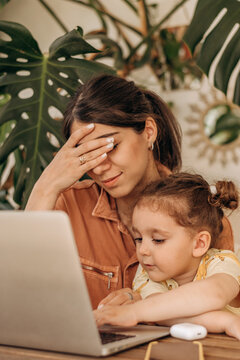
<box><xmin>134</xmin><ymin>274</ymin><xmax>239</xmax><ymax>322</ymax></box>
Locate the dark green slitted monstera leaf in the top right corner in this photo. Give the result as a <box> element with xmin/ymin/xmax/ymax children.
<box><xmin>184</xmin><ymin>0</ymin><xmax>240</xmax><ymax>105</ymax></box>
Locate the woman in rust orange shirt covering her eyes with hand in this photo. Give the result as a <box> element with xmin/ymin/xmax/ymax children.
<box><xmin>26</xmin><ymin>75</ymin><xmax>233</xmax><ymax>308</ymax></box>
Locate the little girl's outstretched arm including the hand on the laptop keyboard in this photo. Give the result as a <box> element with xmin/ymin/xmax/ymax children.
<box><xmin>95</xmin><ymin>274</ymin><xmax>239</xmax><ymax>326</ymax></box>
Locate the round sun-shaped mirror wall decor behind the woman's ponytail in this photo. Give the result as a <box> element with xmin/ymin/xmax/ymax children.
<box><xmin>185</xmin><ymin>83</ymin><xmax>240</xmax><ymax>166</ymax></box>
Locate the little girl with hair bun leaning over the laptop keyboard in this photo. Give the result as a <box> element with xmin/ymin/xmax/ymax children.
<box><xmin>95</xmin><ymin>173</ymin><xmax>240</xmax><ymax>340</ymax></box>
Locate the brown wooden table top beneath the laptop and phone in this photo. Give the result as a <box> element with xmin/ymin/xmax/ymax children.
<box><xmin>0</xmin><ymin>334</ymin><xmax>240</xmax><ymax>360</ymax></box>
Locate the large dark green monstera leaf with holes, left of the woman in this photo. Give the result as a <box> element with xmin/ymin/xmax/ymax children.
<box><xmin>0</xmin><ymin>21</ymin><xmax>115</xmax><ymax>206</ymax></box>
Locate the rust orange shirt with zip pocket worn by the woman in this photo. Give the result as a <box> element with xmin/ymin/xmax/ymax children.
<box><xmin>55</xmin><ymin>180</ymin><xmax>233</xmax><ymax>309</ymax></box>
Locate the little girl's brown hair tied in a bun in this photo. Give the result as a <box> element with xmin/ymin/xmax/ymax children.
<box><xmin>136</xmin><ymin>172</ymin><xmax>239</xmax><ymax>247</ymax></box>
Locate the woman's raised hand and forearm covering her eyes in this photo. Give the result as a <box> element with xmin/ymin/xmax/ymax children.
<box><xmin>26</xmin><ymin>124</ymin><xmax>114</xmax><ymax>210</ymax></box>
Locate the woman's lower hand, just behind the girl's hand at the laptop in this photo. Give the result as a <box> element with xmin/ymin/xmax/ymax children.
<box><xmin>98</xmin><ymin>288</ymin><xmax>141</xmax><ymax>309</ymax></box>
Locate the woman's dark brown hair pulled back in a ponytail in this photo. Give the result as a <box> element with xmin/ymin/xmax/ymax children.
<box><xmin>63</xmin><ymin>75</ymin><xmax>182</xmax><ymax>171</ymax></box>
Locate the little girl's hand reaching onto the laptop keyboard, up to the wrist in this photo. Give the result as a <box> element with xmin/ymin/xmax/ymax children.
<box><xmin>93</xmin><ymin>304</ymin><xmax>138</xmax><ymax>326</ymax></box>
